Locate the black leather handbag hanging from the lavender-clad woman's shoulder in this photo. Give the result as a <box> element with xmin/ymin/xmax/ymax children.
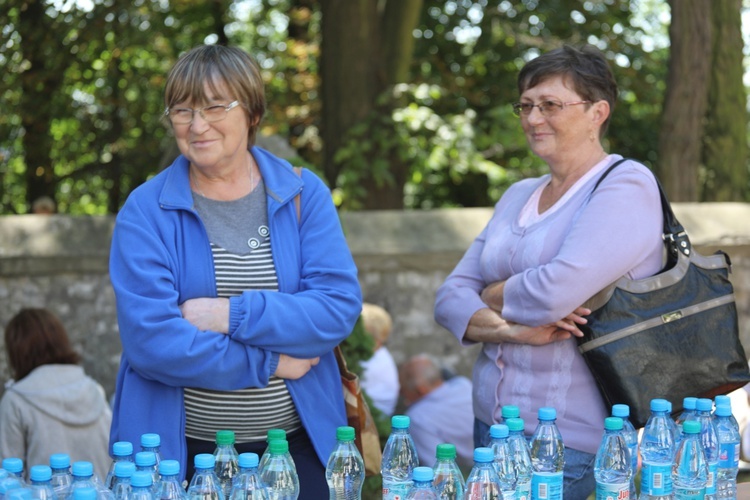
<box><xmin>577</xmin><ymin>160</ymin><xmax>750</xmax><ymax>427</ymax></box>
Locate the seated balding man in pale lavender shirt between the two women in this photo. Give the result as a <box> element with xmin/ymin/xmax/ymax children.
<box><xmin>399</xmin><ymin>354</ymin><xmax>474</xmax><ymax>471</ymax></box>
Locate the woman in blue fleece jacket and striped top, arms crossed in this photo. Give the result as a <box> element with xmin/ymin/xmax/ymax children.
<box><xmin>110</xmin><ymin>46</ymin><xmax>362</xmax><ymax>498</ymax></box>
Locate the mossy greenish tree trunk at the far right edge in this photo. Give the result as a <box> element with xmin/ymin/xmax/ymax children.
<box><xmin>700</xmin><ymin>0</ymin><xmax>748</xmax><ymax>201</ymax></box>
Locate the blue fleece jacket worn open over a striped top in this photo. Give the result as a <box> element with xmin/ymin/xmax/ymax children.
<box><xmin>109</xmin><ymin>147</ymin><xmax>362</xmax><ymax>476</ymax></box>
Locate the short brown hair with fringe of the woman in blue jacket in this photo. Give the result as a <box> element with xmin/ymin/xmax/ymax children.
<box><xmin>164</xmin><ymin>45</ymin><xmax>266</xmax><ymax>146</ymax></box>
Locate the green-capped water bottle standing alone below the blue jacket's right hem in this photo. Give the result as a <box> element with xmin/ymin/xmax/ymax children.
<box><xmin>326</xmin><ymin>426</ymin><xmax>365</xmax><ymax>500</ymax></box>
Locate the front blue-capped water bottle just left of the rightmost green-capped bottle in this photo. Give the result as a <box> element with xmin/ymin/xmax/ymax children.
<box><xmin>638</xmin><ymin>399</ymin><xmax>674</xmax><ymax>500</ymax></box>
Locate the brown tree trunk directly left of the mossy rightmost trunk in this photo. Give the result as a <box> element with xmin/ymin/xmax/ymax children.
<box><xmin>659</xmin><ymin>0</ymin><xmax>712</xmax><ymax>201</ymax></box>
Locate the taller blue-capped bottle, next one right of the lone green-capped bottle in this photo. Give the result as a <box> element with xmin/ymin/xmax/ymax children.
<box><xmin>380</xmin><ymin>415</ymin><xmax>419</xmax><ymax>500</ymax></box>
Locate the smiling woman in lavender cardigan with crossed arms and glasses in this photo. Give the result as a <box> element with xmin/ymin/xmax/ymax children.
<box><xmin>435</xmin><ymin>46</ymin><xmax>664</xmax><ymax>498</ymax></box>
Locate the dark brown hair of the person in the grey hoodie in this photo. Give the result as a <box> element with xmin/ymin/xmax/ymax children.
<box><xmin>5</xmin><ymin>308</ymin><xmax>80</xmax><ymax>380</ymax></box>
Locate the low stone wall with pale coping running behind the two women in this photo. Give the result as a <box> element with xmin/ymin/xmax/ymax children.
<box><xmin>0</xmin><ymin>203</ymin><xmax>750</xmax><ymax>400</ymax></box>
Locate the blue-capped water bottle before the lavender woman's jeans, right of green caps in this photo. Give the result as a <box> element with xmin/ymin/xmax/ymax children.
<box><xmin>530</xmin><ymin>407</ymin><xmax>565</xmax><ymax>500</ymax></box>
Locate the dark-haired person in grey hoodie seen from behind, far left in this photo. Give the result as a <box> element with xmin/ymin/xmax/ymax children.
<box><xmin>0</xmin><ymin>308</ymin><xmax>112</xmax><ymax>478</ymax></box>
